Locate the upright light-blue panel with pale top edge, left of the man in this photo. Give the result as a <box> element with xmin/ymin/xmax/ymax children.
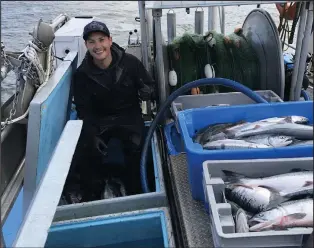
<box><xmin>23</xmin><ymin>51</ymin><xmax>78</xmax><ymax>214</ymax></box>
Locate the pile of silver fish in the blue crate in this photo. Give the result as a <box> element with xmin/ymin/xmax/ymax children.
<box><xmin>193</xmin><ymin>116</ymin><xmax>313</xmax><ymax>150</ymax></box>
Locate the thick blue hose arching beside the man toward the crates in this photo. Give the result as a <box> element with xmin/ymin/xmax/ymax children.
<box><xmin>140</xmin><ymin>78</ymin><xmax>268</xmax><ymax>193</ymax></box>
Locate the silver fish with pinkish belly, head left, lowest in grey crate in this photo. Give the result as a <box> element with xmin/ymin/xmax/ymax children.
<box><xmin>249</xmin><ymin>199</ymin><xmax>313</xmax><ymax>232</ymax></box>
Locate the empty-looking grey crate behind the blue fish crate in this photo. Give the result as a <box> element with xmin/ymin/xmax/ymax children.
<box><xmin>171</xmin><ymin>90</ymin><xmax>283</xmax><ymax>131</ymax></box>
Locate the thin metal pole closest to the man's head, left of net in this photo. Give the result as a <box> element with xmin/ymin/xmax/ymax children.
<box><xmin>138</xmin><ymin>1</ymin><xmax>150</xmax><ymax>71</ymax></box>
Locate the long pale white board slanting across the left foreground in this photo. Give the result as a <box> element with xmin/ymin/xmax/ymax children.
<box><xmin>13</xmin><ymin>120</ymin><xmax>83</xmax><ymax>247</ymax></box>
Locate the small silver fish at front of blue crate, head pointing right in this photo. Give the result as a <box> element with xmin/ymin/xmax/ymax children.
<box><xmin>244</xmin><ymin>134</ymin><xmax>294</xmax><ymax>147</ymax></box>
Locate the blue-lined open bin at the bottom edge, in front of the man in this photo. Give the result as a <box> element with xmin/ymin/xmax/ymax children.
<box><xmin>45</xmin><ymin>208</ymin><xmax>175</xmax><ymax>248</ymax></box>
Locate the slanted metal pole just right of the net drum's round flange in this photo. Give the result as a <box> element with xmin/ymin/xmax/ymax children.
<box><xmin>289</xmin><ymin>3</ymin><xmax>306</xmax><ymax>101</ymax></box>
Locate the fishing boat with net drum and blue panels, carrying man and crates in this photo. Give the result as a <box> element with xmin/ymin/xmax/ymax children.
<box><xmin>1</xmin><ymin>1</ymin><xmax>313</xmax><ymax>247</ymax></box>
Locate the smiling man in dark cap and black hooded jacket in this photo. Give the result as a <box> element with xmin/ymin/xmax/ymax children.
<box><xmin>70</xmin><ymin>21</ymin><xmax>156</xmax><ymax>201</ymax></box>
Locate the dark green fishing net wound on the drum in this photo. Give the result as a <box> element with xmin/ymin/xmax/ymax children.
<box><xmin>168</xmin><ymin>29</ymin><xmax>260</xmax><ymax>94</ymax></box>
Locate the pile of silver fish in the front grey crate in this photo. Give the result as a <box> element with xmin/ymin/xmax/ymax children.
<box><xmin>223</xmin><ymin>169</ymin><xmax>313</xmax><ymax>233</ymax></box>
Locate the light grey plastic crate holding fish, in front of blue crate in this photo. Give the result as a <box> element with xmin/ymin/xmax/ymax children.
<box><xmin>203</xmin><ymin>157</ymin><xmax>313</xmax><ymax>248</ymax></box>
